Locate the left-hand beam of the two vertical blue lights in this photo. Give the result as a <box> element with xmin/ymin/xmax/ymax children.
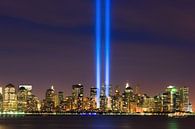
<box><xmin>96</xmin><ymin>0</ymin><xmax>101</xmax><ymax>108</ymax></box>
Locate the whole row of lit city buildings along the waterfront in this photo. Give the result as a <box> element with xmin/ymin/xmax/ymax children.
<box><xmin>0</xmin><ymin>83</ymin><xmax>192</xmax><ymax>113</ymax></box>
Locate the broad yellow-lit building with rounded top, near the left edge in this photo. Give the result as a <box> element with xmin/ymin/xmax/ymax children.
<box><xmin>3</xmin><ymin>84</ymin><xmax>17</xmax><ymax>112</ymax></box>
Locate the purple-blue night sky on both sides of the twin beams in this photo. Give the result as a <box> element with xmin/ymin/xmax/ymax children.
<box><xmin>0</xmin><ymin>0</ymin><xmax>195</xmax><ymax>108</ymax></box>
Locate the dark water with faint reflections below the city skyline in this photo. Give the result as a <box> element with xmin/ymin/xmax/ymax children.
<box><xmin>0</xmin><ymin>116</ymin><xmax>194</xmax><ymax>129</ymax></box>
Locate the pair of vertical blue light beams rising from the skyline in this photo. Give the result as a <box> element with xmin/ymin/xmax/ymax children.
<box><xmin>96</xmin><ymin>0</ymin><xmax>110</xmax><ymax>108</ymax></box>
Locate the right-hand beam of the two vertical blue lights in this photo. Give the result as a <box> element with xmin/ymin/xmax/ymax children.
<box><xmin>105</xmin><ymin>0</ymin><xmax>110</xmax><ymax>97</ymax></box>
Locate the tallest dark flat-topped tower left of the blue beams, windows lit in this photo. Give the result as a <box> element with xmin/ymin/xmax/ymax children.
<box><xmin>72</xmin><ymin>84</ymin><xmax>83</xmax><ymax>111</ymax></box>
